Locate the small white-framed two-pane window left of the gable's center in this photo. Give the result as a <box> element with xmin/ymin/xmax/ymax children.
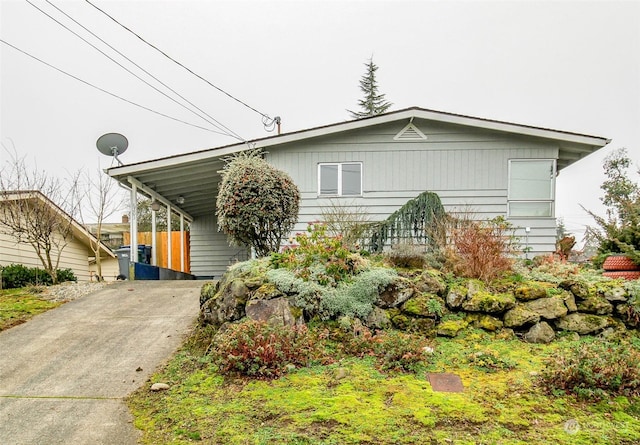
<box><xmin>318</xmin><ymin>162</ymin><xmax>362</xmax><ymax>196</ymax></box>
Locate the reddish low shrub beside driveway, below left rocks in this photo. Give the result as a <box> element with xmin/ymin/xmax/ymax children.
<box><xmin>211</xmin><ymin>321</ymin><xmax>315</xmax><ymax>378</ymax></box>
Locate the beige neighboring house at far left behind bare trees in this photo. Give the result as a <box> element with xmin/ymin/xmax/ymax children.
<box><xmin>0</xmin><ymin>191</ymin><xmax>118</xmax><ymax>281</ymax></box>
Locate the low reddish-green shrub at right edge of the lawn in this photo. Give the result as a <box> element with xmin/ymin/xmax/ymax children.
<box><xmin>540</xmin><ymin>339</ymin><xmax>640</xmax><ymax>400</ymax></box>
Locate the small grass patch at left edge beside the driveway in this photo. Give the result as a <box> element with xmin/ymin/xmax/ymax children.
<box><xmin>0</xmin><ymin>287</ymin><xmax>62</xmax><ymax>331</ymax></box>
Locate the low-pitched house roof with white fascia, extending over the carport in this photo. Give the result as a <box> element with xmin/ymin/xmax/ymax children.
<box><xmin>107</xmin><ymin>107</ymin><xmax>610</xmax><ymax>219</ymax></box>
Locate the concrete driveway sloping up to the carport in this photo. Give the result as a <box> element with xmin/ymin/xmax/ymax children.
<box><xmin>0</xmin><ymin>281</ymin><xmax>202</xmax><ymax>445</ymax></box>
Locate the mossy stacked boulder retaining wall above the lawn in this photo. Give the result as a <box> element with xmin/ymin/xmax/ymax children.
<box><xmin>200</xmin><ymin>264</ymin><xmax>639</xmax><ymax>343</ymax></box>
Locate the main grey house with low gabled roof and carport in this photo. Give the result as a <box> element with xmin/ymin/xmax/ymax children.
<box><xmin>108</xmin><ymin>108</ymin><xmax>609</xmax><ymax>277</ymax></box>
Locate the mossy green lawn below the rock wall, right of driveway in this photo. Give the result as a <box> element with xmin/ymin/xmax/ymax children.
<box><xmin>128</xmin><ymin>330</ymin><xmax>640</xmax><ymax>445</ymax></box>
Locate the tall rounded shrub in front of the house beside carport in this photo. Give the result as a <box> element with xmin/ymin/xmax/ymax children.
<box><xmin>216</xmin><ymin>151</ymin><xmax>300</xmax><ymax>256</ymax></box>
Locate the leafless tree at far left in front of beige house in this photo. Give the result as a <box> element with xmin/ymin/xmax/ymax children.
<box><xmin>0</xmin><ymin>144</ymin><xmax>79</xmax><ymax>284</ymax></box>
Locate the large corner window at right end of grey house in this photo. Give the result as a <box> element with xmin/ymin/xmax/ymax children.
<box><xmin>508</xmin><ymin>159</ymin><xmax>556</xmax><ymax>217</ymax></box>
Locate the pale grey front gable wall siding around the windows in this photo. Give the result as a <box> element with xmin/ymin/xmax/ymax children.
<box><xmin>266</xmin><ymin>119</ymin><xmax>558</xmax><ymax>253</ymax></box>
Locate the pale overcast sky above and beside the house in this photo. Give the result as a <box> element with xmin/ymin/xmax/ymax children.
<box><xmin>0</xmin><ymin>0</ymin><xmax>640</xmax><ymax>238</ymax></box>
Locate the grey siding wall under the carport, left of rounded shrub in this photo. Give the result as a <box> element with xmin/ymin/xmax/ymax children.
<box><xmin>190</xmin><ymin>212</ymin><xmax>248</xmax><ymax>278</ymax></box>
